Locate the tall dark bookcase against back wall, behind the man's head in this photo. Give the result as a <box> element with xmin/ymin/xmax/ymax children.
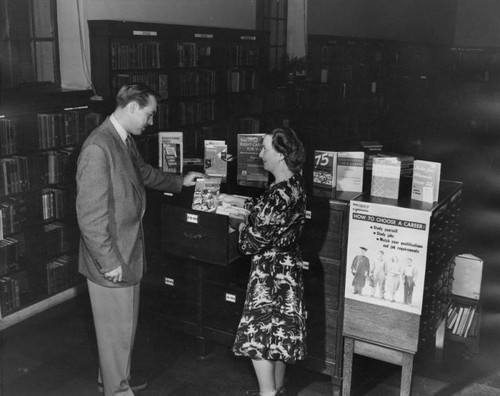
<box><xmin>88</xmin><ymin>20</ymin><xmax>276</xmax><ymax>164</ymax></box>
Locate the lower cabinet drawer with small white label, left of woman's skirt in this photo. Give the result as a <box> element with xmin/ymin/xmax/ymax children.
<box><xmin>203</xmin><ymin>282</ymin><xmax>245</xmax><ymax>334</ymax></box>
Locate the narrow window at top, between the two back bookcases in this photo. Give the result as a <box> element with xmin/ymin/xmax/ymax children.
<box><xmin>256</xmin><ymin>0</ymin><xmax>288</xmax><ymax>71</ymax></box>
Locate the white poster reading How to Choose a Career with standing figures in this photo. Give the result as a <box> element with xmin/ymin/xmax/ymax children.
<box><xmin>345</xmin><ymin>201</ymin><xmax>431</xmax><ymax>315</ymax></box>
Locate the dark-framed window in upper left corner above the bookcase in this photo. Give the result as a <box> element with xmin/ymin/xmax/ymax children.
<box><xmin>0</xmin><ymin>0</ymin><xmax>61</xmax><ymax>90</ymax></box>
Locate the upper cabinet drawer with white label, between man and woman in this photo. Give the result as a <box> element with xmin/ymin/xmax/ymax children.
<box><xmin>161</xmin><ymin>203</ymin><xmax>240</xmax><ymax>266</ymax></box>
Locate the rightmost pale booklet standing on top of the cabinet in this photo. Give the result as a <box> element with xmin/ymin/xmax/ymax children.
<box><xmin>411</xmin><ymin>160</ymin><xmax>441</xmax><ymax>203</ymax></box>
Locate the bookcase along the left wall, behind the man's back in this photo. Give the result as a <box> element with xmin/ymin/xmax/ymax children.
<box><xmin>0</xmin><ymin>91</ymin><xmax>102</xmax><ymax>330</ymax></box>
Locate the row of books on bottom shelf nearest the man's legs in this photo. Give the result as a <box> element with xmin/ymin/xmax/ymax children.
<box><xmin>46</xmin><ymin>254</ymin><xmax>78</xmax><ymax>296</ymax></box>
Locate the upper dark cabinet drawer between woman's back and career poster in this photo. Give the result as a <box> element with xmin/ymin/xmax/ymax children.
<box><xmin>300</xmin><ymin>207</ymin><xmax>343</xmax><ymax>260</ymax></box>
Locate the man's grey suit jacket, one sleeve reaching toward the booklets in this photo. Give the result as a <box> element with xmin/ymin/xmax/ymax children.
<box><xmin>76</xmin><ymin>118</ymin><xmax>183</xmax><ymax>287</ymax></box>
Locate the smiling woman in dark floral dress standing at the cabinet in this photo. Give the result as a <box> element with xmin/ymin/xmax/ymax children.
<box><xmin>221</xmin><ymin>128</ymin><xmax>306</xmax><ymax>396</ymax></box>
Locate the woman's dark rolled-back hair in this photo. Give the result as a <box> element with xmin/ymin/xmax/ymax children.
<box><xmin>266</xmin><ymin>128</ymin><xmax>306</xmax><ymax>173</ymax></box>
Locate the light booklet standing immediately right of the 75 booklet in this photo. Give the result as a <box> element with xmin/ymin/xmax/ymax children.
<box><xmin>337</xmin><ymin>151</ymin><xmax>365</xmax><ymax>192</ymax></box>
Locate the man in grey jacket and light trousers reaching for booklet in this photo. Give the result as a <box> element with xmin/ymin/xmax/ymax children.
<box><xmin>76</xmin><ymin>84</ymin><xmax>203</xmax><ymax>396</ymax></box>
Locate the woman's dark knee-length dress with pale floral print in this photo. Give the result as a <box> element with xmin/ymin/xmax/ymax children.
<box><xmin>233</xmin><ymin>174</ymin><xmax>306</xmax><ymax>363</ymax></box>
